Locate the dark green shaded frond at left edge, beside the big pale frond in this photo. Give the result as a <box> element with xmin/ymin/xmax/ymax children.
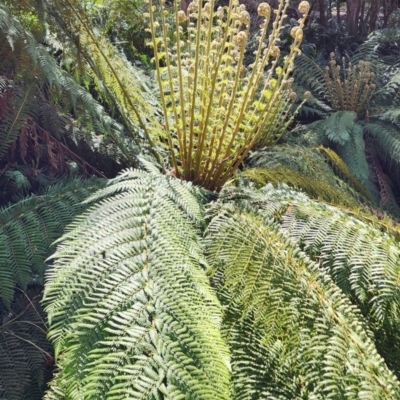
<box><xmin>0</xmin><ymin>179</ymin><xmax>102</xmax><ymax>307</ymax></box>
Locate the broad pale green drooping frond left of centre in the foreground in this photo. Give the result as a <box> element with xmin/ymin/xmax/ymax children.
<box><xmin>44</xmin><ymin>171</ymin><xmax>230</xmax><ymax>400</ymax></box>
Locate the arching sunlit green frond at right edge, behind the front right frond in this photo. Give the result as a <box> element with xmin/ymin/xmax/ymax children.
<box><xmin>225</xmin><ymin>185</ymin><xmax>400</xmax><ymax>376</ymax></box>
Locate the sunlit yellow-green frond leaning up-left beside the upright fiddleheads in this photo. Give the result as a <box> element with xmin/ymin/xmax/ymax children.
<box><xmin>38</xmin><ymin>0</ymin><xmax>164</xmax><ymax>166</ymax></box>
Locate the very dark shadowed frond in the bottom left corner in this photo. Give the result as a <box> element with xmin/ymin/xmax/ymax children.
<box><xmin>0</xmin><ymin>287</ymin><xmax>53</xmax><ymax>400</ymax></box>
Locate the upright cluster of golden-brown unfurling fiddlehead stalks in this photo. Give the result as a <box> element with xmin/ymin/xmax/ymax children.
<box><xmin>146</xmin><ymin>0</ymin><xmax>309</xmax><ymax>191</ymax></box>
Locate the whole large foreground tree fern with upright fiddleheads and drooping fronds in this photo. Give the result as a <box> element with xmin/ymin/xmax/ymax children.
<box><xmin>0</xmin><ymin>0</ymin><xmax>400</xmax><ymax>400</ymax></box>
